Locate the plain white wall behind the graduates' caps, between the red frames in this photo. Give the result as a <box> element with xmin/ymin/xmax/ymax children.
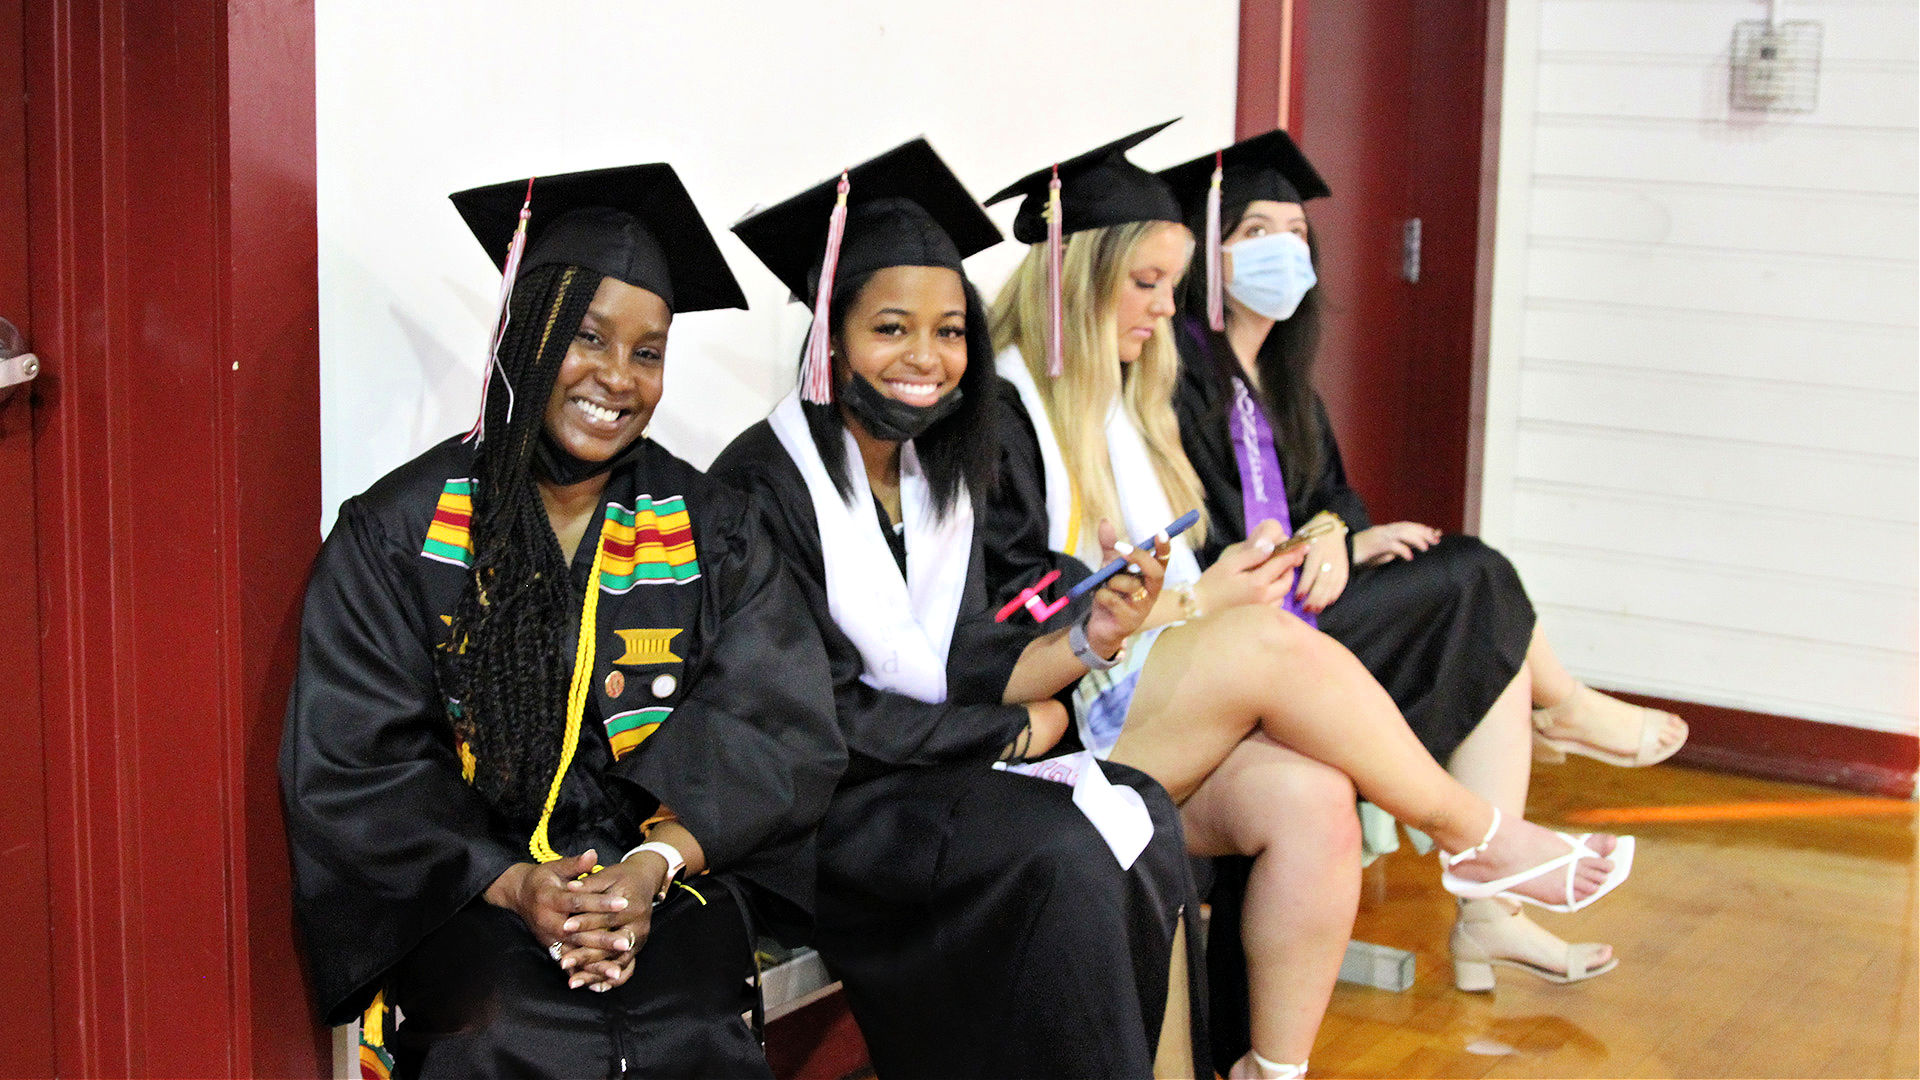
<box><xmin>317</xmin><ymin>0</ymin><xmax>1238</xmax><ymax>528</ymax></box>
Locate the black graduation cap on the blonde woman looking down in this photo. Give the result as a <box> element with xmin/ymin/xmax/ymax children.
<box><xmin>987</xmin><ymin>117</ymin><xmax>1183</xmax><ymax>244</ymax></box>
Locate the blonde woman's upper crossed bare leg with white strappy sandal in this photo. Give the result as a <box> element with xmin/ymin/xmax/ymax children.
<box><xmin>1114</xmin><ymin>607</ymin><xmax>1613</xmax><ymax>903</ymax></box>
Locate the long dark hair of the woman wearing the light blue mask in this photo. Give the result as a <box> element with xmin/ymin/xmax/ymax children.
<box><xmin>1181</xmin><ymin>190</ymin><xmax>1327</xmax><ymax>492</ymax></box>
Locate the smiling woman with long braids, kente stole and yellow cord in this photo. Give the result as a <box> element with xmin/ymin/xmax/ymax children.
<box><xmin>280</xmin><ymin>165</ymin><xmax>845</xmax><ymax>1078</ymax></box>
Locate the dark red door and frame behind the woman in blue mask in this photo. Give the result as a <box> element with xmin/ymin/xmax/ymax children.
<box><xmin>1236</xmin><ymin>0</ymin><xmax>1503</xmax><ymax>530</ymax></box>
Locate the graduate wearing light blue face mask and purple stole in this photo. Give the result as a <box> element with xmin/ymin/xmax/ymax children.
<box><xmin>1162</xmin><ymin>131</ymin><xmax>1684</xmax><ymax>990</ymax></box>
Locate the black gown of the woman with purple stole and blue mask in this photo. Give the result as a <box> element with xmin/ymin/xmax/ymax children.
<box><xmin>1173</xmin><ymin>327</ymin><xmax>1534</xmax><ymax>763</ymax></box>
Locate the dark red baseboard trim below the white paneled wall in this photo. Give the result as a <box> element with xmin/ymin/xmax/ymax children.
<box><xmin>1609</xmin><ymin>690</ymin><xmax>1920</xmax><ymax>799</ymax></box>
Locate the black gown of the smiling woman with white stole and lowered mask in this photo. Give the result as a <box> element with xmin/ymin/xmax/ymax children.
<box><xmin>714</xmin><ymin>386</ymin><xmax>1212</xmax><ymax>1078</ymax></box>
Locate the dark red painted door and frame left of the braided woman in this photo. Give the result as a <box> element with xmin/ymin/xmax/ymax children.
<box><xmin>22</xmin><ymin>0</ymin><xmax>326</xmax><ymax>1076</ymax></box>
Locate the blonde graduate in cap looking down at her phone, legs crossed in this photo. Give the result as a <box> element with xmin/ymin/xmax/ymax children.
<box><xmin>989</xmin><ymin>125</ymin><xmax>1632</xmax><ymax>1080</ymax></box>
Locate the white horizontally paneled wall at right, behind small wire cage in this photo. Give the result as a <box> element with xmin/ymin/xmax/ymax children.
<box><xmin>1480</xmin><ymin>0</ymin><xmax>1920</xmax><ymax>732</ymax></box>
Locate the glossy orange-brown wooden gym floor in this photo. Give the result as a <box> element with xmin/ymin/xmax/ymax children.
<box><xmin>1311</xmin><ymin>757</ymin><xmax>1920</xmax><ymax>1076</ymax></box>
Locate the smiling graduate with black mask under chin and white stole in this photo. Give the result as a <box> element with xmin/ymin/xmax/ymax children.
<box><xmin>714</xmin><ymin>140</ymin><xmax>1212</xmax><ymax>1078</ymax></box>
